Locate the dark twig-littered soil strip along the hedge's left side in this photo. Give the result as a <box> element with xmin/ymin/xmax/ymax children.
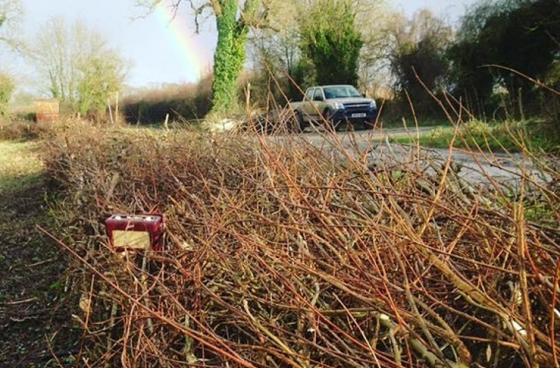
<box><xmin>0</xmin><ymin>166</ymin><xmax>81</xmax><ymax>368</ymax></box>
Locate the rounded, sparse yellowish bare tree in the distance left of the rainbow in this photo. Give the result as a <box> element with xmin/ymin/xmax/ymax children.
<box><xmin>26</xmin><ymin>17</ymin><xmax>127</xmax><ymax>113</ymax></box>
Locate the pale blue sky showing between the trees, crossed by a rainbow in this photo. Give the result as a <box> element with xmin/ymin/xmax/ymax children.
<box><xmin>0</xmin><ymin>0</ymin><xmax>475</xmax><ymax>93</ymax></box>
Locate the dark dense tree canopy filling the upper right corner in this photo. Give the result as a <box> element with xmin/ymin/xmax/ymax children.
<box><xmin>449</xmin><ymin>0</ymin><xmax>560</xmax><ymax>116</ymax></box>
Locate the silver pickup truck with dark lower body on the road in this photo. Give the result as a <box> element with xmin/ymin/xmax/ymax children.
<box><xmin>290</xmin><ymin>85</ymin><xmax>377</xmax><ymax>131</ymax></box>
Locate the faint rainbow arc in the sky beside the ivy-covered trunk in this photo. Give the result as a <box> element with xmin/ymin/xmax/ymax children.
<box><xmin>155</xmin><ymin>0</ymin><xmax>209</xmax><ymax>82</ymax></box>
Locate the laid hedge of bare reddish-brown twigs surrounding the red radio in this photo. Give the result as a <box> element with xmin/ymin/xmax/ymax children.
<box><xmin>41</xmin><ymin>118</ymin><xmax>560</xmax><ymax>367</ymax></box>
